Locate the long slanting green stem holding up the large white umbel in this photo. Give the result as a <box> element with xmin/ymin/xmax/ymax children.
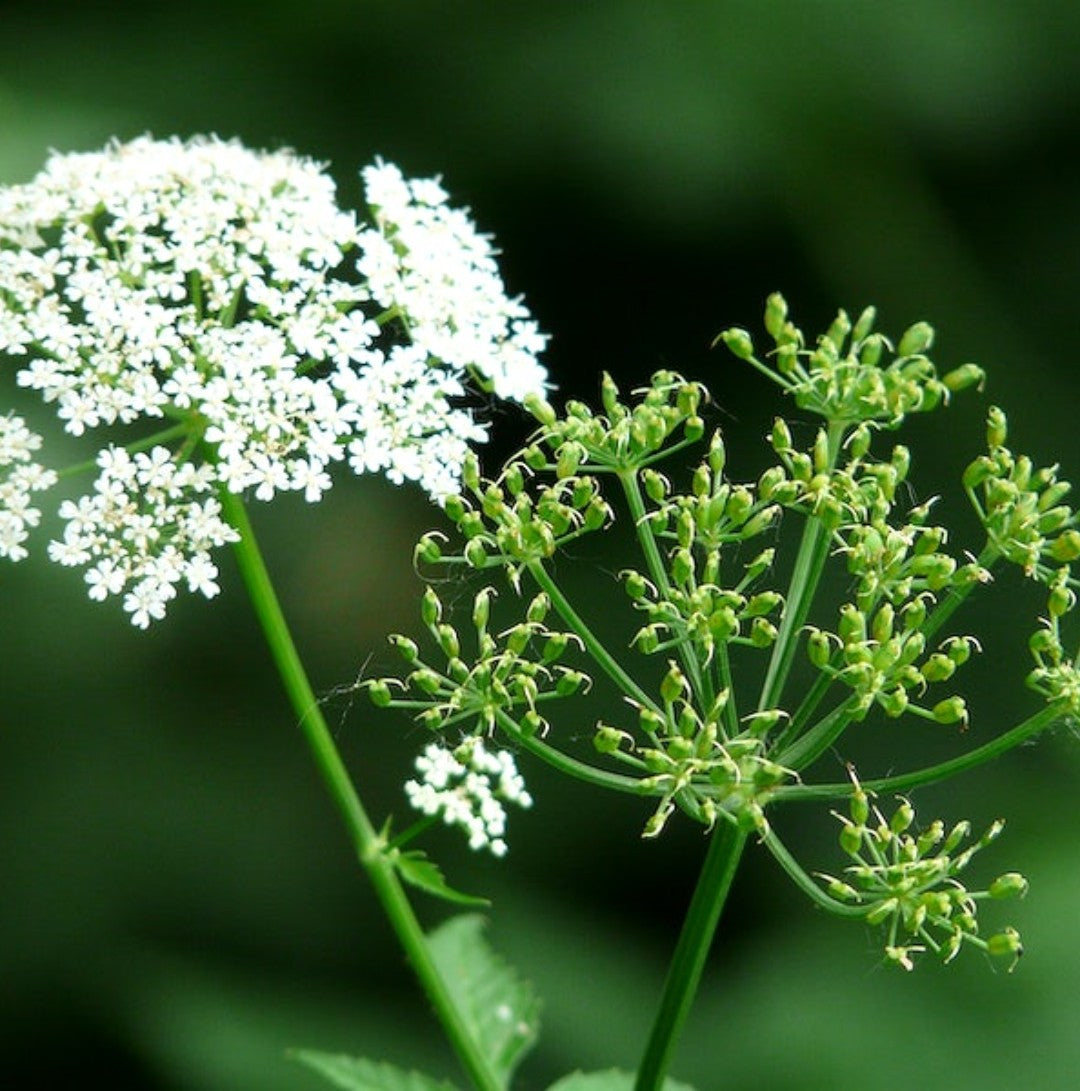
<box><xmin>220</xmin><ymin>489</ymin><xmax>504</xmax><ymax>1091</ymax></box>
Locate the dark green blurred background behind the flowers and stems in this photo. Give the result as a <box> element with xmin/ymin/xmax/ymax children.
<box><xmin>0</xmin><ymin>0</ymin><xmax>1080</xmax><ymax>1091</ymax></box>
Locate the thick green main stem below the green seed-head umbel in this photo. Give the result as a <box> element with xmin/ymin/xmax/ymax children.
<box><xmin>634</xmin><ymin>822</ymin><xmax>747</xmax><ymax>1091</ymax></box>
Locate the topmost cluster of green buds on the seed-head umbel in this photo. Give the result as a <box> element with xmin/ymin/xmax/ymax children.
<box><xmin>718</xmin><ymin>293</ymin><xmax>985</xmax><ymax>428</ymax></box>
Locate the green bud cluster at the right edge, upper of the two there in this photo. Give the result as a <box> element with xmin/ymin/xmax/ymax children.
<box><xmin>963</xmin><ymin>406</ymin><xmax>1080</xmax><ymax>583</ymax></box>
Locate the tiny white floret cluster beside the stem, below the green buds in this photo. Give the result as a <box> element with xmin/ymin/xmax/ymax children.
<box><xmin>405</xmin><ymin>735</ymin><xmax>532</xmax><ymax>856</ymax></box>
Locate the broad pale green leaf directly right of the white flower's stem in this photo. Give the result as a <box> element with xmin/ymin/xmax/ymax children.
<box><xmin>429</xmin><ymin>913</ymin><xmax>540</xmax><ymax>1084</ymax></box>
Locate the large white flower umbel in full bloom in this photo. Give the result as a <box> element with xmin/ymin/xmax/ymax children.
<box><xmin>0</xmin><ymin>136</ymin><xmax>545</xmax><ymax>626</ymax></box>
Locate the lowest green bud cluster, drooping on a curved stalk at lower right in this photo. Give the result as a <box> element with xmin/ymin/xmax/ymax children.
<box><xmin>820</xmin><ymin>781</ymin><xmax>1028</xmax><ymax>970</ymax></box>
